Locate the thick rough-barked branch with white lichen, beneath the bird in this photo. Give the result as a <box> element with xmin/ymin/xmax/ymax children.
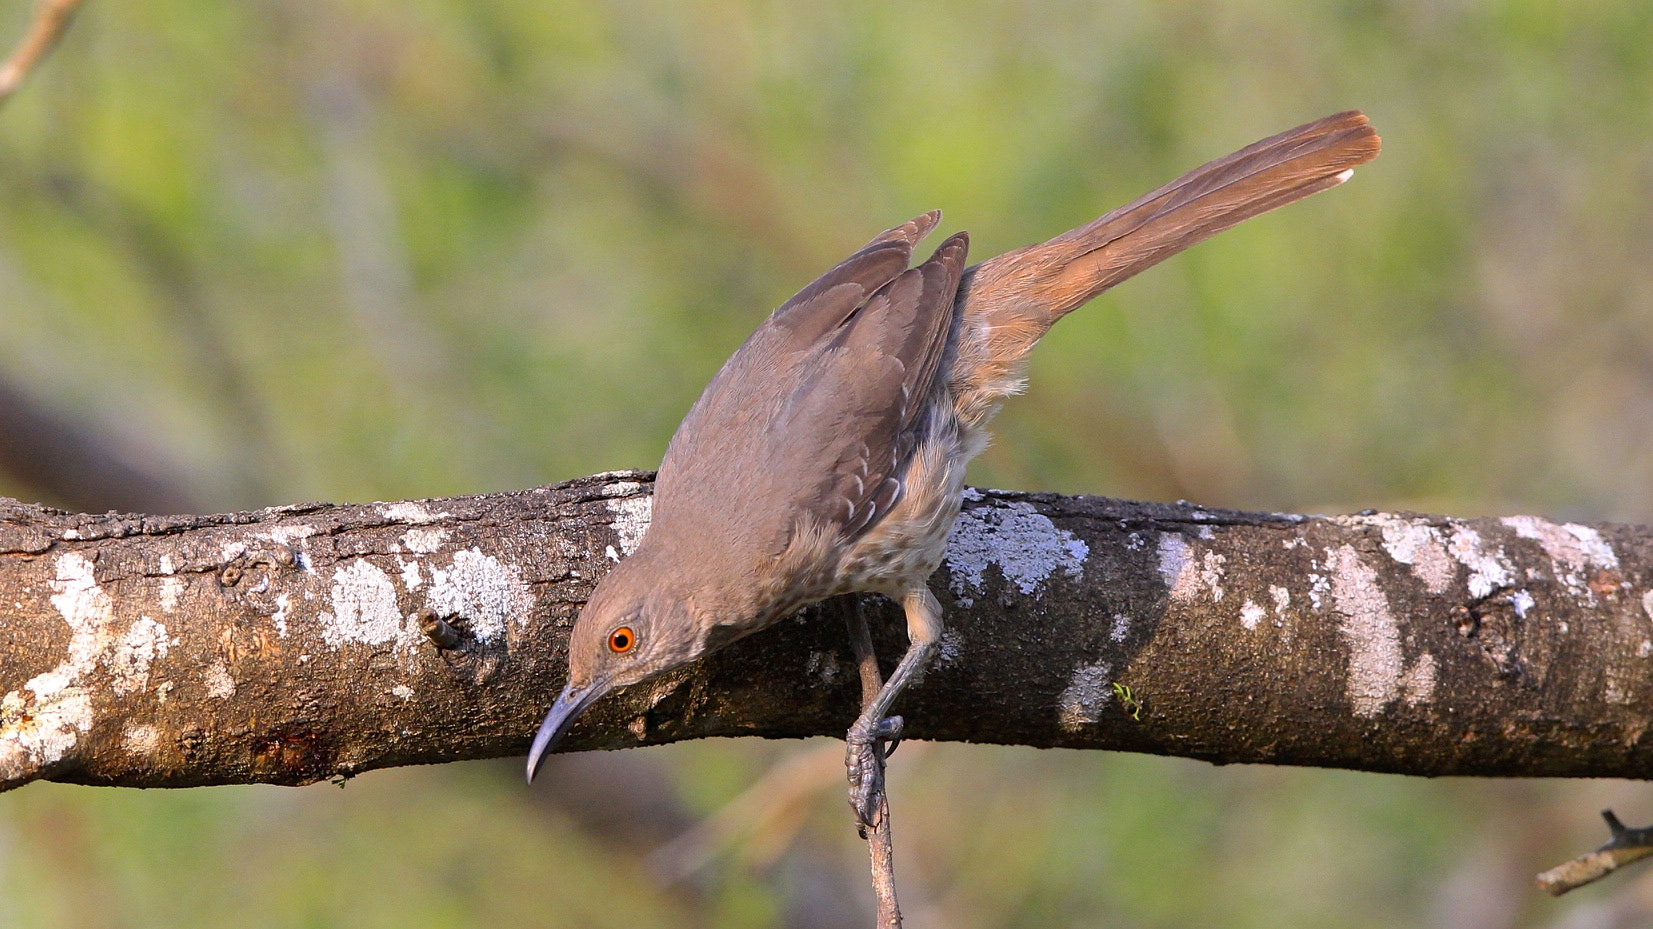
<box><xmin>0</xmin><ymin>473</ymin><xmax>1653</xmax><ymax>787</ymax></box>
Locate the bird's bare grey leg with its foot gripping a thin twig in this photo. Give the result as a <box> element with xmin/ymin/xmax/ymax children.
<box><xmin>845</xmin><ymin>587</ymin><xmax>942</xmax><ymax>835</ymax></box>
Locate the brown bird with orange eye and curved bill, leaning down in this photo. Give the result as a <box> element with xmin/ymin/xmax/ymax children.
<box><xmin>527</xmin><ymin>111</ymin><xmax>1379</xmax><ymax>823</ymax></box>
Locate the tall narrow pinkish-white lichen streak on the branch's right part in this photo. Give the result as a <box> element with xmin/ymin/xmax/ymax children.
<box><xmin>1329</xmin><ymin>545</ymin><xmax>1403</xmax><ymax>717</ymax></box>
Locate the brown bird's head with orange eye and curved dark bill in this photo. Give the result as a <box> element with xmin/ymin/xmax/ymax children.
<box><xmin>527</xmin><ymin>550</ymin><xmax>707</xmax><ymax>782</ymax></box>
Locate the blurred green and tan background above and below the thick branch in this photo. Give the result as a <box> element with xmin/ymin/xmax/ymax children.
<box><xmin>0</xmin><ymin>0</ymin><xmax>1653</xmax><ymax>929</ymax></box>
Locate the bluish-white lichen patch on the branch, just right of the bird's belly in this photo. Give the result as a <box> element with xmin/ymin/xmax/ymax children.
<box><xmin>946</xmin><ymin>501</ymin><xmax>1091</xmax><ymax>605</ymax></box>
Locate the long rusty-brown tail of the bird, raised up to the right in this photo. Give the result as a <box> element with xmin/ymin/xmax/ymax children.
<box><xmin>952</xmin><ymin>111</ymin><xmax>1379</xmax><ymax>428</ymax></box>
